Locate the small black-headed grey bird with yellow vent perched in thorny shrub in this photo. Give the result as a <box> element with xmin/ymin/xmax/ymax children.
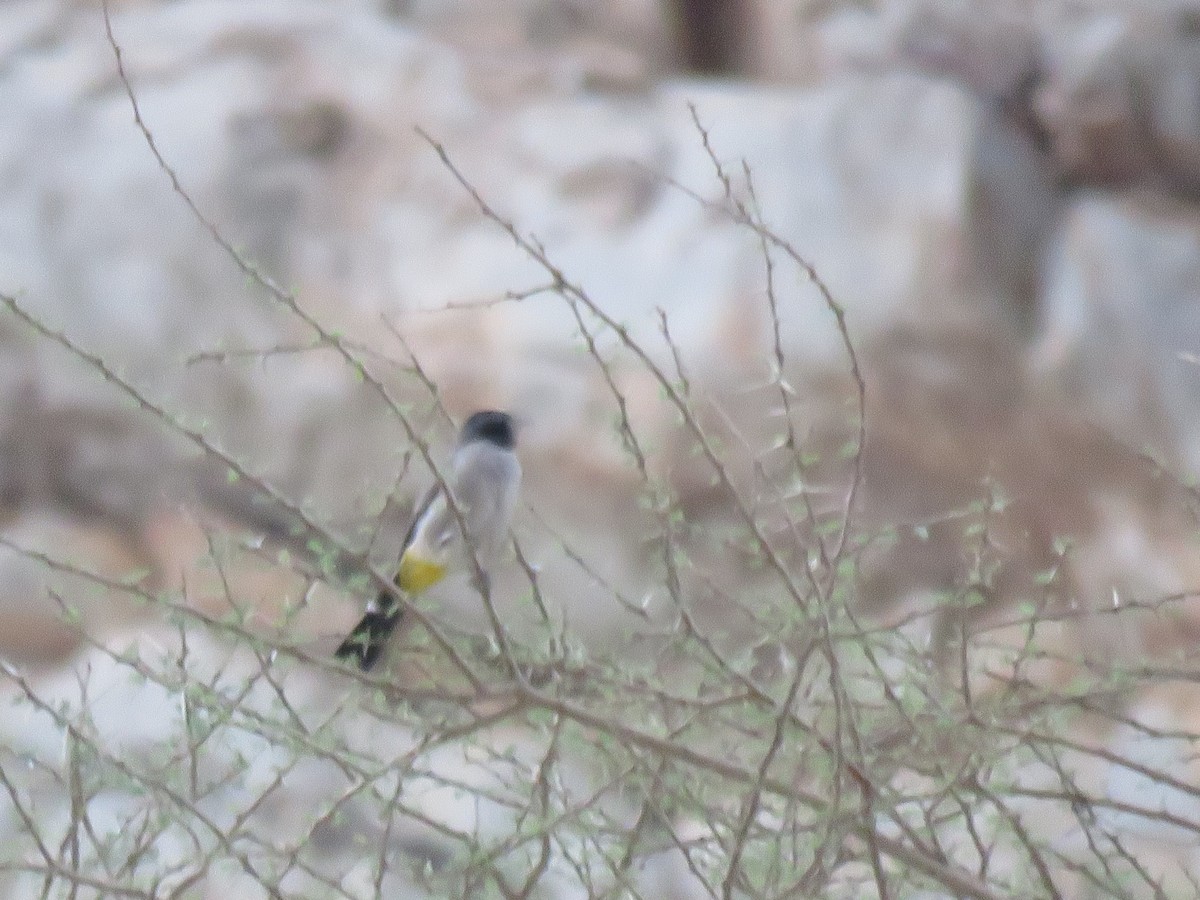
<box><xmin>335</xmin><ymin>409</ymin><xmax>521</xmax><ymax>672</ymax></box>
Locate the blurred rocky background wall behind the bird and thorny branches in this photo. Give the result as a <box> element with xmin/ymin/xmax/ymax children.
<box><xmin>0</xmin><ymin>0</ymin><xmax>1200</xmax><ymax>895</ymax></box>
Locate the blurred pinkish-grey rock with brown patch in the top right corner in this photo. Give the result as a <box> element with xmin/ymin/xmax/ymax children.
<box><xmin>792</xmin><ymin>0</ymin><xmax>1200</xmax><ymax>198</ymax></box>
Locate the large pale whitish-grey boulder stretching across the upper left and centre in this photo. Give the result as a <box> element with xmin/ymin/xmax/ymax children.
<box><xmin>0</xmin><ymin>2</ymin><xmax>1048</xmax><ymax>372</ymax></box>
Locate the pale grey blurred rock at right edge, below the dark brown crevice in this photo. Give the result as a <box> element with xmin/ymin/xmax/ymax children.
<box><xmin>1034</xmin><ymin>192</ymin><xmax>1200</xmax><ymax>470</ymax></box>
